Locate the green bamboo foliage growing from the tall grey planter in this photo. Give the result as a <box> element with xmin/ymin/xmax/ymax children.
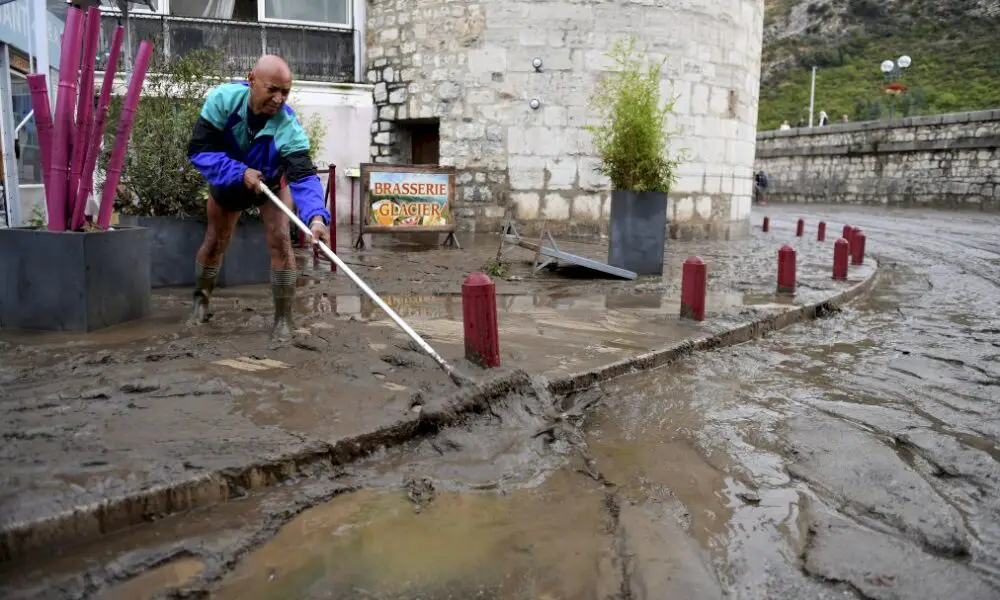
<box><xmin>587</xmin><ymin>36</ymin><xmax>678</xmax><ymax>192</ymax></box>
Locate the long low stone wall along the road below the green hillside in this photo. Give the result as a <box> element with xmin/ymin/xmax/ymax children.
<box><xmin>755</xmin><ymin>110</ymin><xmax>1000</xmax><ymax>210</ymax></box>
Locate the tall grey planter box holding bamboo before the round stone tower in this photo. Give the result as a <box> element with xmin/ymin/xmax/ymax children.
<box><xmin>608</xmin><ymin>192</ymin><xmax>667</xmax><ymax>275</ymax></box>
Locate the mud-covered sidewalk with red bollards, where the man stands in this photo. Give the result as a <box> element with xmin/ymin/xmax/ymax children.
<box><xmin>0</xmin><ymin>224</ymin><xmax>874</xmax><ymax>560</ymax></box>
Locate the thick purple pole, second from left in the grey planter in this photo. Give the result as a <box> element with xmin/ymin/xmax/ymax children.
<box><xmin>46</xmin><ymin>7</ymin><xmax>83</xmax><ymax>231</ymax></box>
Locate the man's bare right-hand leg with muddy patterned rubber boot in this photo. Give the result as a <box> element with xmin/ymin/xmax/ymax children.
<box><xmin>260</xmin><ymin>187</ymin><xmax>298</xmax><ymax>342</ymax></box>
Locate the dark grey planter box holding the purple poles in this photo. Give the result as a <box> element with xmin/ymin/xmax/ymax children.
<box><xmin>0</xmin><ymin>227</ymin><xmax>152</xmax><ymax>332</ymax></box>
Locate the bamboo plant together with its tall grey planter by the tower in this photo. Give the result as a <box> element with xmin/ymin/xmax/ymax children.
<box><xmin>588</xmin><ymin>37</ymin><xmax>678</xmax><ymax>275</ymax></box>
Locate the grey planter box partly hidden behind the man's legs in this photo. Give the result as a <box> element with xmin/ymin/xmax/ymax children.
<box><xmin>120</xmin><ymin>216</ymin><xmax>271</xmax><ymax>288</ymax></box>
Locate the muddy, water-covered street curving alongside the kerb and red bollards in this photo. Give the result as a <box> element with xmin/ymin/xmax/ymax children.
<box><xmin>0</xmin><ymin>207</ymin><xmax>1000</xmax><ymax>600</ymax></box>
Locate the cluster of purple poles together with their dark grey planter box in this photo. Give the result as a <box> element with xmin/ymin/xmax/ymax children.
<box><xmin>0</xmin><ymin>6</ymin><xmax>153</xmax><ymax>331</ymax></box>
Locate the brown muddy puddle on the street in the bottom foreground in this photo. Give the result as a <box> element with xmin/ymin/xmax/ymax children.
<box><xmin>212</xmin><ymin>471</ymin><xmax>617</xmax><ymax>600</ymax></box>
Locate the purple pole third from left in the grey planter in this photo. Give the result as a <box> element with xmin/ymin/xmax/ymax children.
<box><xmin>69</xmin><ymin>6</ymin><xmax>101</xmax><ymax>231</ymax></box>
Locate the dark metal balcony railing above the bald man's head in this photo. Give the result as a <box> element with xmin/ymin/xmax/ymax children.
<box><xmin>97</xmin><ymin>15</ymin><xmax>355</xmax><ymax>83</ymax></box>
